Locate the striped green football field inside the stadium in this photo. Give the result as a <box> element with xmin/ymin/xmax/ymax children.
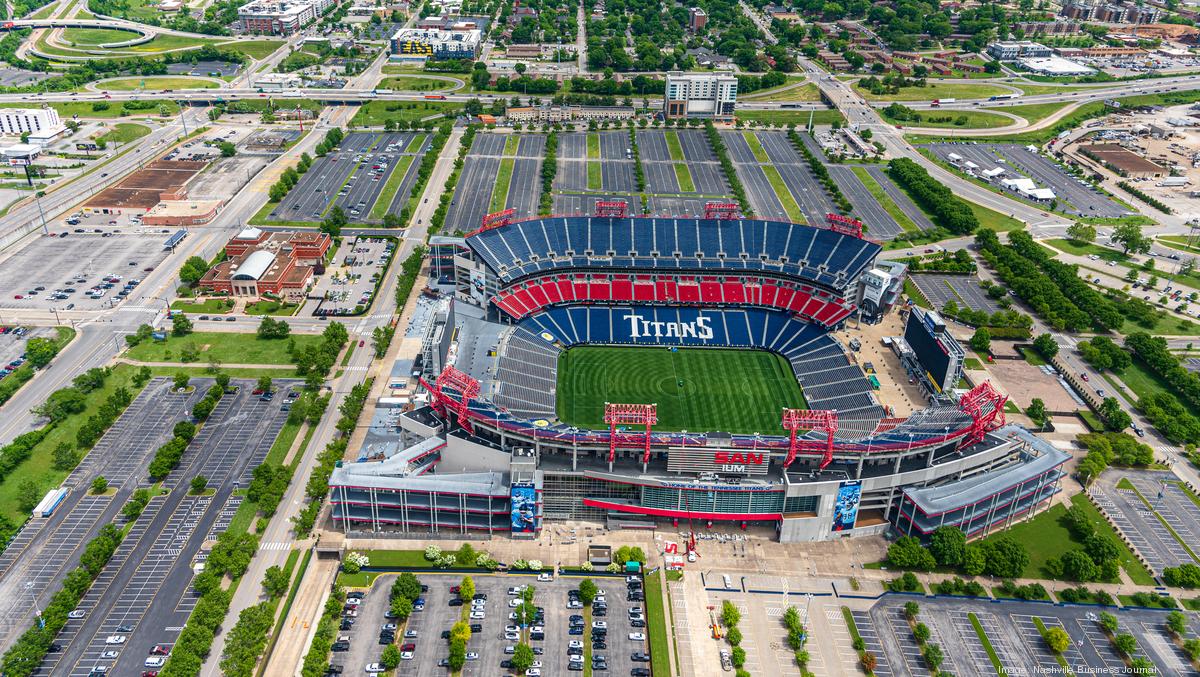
<box><xmin>558</xmin><ymin>346</ymin><xmax>805</xmax><ymax>433</ymax></box>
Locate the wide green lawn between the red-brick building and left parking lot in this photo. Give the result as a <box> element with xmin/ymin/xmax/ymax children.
<box><xmin>126</xmin><ymin>331</ymin><xmax>320</xmax><ymax>365</ymax></box>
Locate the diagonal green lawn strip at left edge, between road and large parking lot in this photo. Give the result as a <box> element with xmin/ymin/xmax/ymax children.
<box><xmin>0</xmin><ymin>365</ymin><xmax>138</xmax><ymax>525</ymax></box>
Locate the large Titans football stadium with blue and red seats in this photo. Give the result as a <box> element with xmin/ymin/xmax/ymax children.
<box><xmin>330</xmin><ymin>203</ymin><xmax>1069</xmax><ymax>541</ymax></box>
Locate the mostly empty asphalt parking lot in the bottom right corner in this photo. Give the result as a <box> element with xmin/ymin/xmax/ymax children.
<box><xmin>859</xmin><ymin>595</ymin><xmax>1195</xmax><ymax>677</ymax></box>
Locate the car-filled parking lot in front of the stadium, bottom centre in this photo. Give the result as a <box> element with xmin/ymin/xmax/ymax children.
<box><xmin>331</xmin><ymin>574</ymin><xmax>649</xmax><ymax>677</ymax></box>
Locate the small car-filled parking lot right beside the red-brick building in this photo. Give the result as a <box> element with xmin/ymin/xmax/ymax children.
<box><xmin>312</xmin><ymin>238</ymin><xmax>396</xmax><ymax>314</ymax></box>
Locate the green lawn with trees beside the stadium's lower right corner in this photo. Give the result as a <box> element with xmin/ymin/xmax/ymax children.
<box><xmin>988</xmin><ymin>493</ymin><xmax>1154</xmax><ymax>586</ymax></box>
